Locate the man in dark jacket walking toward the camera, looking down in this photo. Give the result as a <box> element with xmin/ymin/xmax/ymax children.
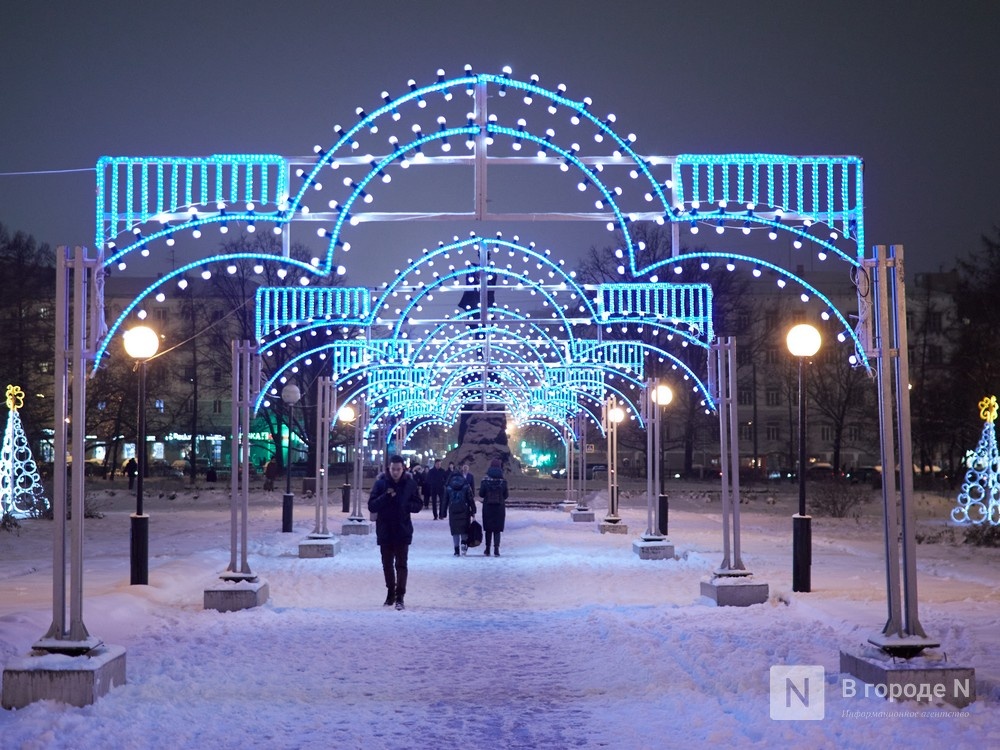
<box><xmin>368</xmin><ymin>456</ymin><xmax>422</xmax><ymax>609</ymax></box>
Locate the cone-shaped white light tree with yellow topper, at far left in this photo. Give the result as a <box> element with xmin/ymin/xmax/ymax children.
<box><xmin>0</xmin><ymin>385</ymin><xmax>49</xmax><ymax>520</ymax></box>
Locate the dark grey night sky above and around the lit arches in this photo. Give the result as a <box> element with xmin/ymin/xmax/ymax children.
<box><xmin>0</xmin><ymin>0</ymin><xmax>1000</xmax><ymax>270</ymax></box>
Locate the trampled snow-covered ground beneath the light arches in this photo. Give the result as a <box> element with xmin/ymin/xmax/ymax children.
<box><xmin>0</xmin><ymin>489</ymin><xmax>1000</xmax><ymax>750</ymax></box>
